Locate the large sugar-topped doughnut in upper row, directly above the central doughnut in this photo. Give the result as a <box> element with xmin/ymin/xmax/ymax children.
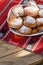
<box><xmin>24</xmin><ymin>3</ymin><xmax>39</xmax><ymax>17</ymax></box>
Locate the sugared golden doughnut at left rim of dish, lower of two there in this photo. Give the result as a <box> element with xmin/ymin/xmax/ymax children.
<box><xmin>8</xmin><ymin>17</ymin><xmax>23</xmax><ymax>28</ymax></box>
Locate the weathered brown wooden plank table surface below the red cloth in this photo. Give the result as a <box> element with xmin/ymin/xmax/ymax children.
<box><xmin>0</xmin><ymin>40</ymin><xmax>43</xmax><ymax>65</ymax></box>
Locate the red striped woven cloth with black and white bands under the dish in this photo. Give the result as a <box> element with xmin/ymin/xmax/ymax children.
<box><xmin>0</xmin><ymin>0</ymin><xmax>43</xmax><ymax>54</ymax></box>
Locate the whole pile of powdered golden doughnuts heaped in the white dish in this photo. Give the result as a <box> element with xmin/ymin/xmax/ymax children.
<box><xmin>8</xmin><ymin>1</ymin><xmax>43</xmax><ymax>35</ymax></box>
